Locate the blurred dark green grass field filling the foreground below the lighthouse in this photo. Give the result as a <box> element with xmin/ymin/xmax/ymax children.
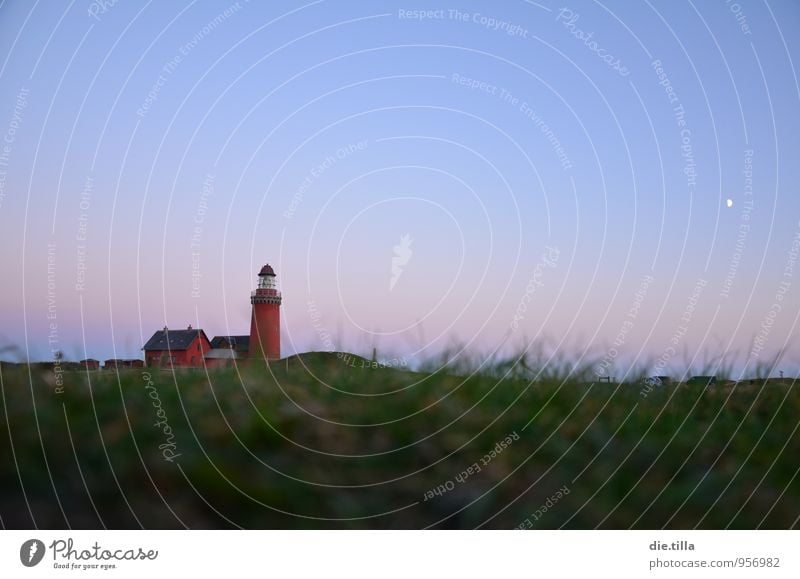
<box><xmin>0</xmin><ymin>353</ymin><xmax>800</xmax><ymax>529</ymax></box>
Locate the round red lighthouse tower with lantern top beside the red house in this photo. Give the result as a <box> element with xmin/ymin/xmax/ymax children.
<box><xmin>249</xmin><ymin>264</ymin><xmax>281</xmax><ymax>360</ymax></box>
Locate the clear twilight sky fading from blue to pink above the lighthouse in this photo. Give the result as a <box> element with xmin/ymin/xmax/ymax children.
<box><xmin>0</xmin><ymin>0</ymin><xmax>800</xmax><ymax>376</ymax></box>
